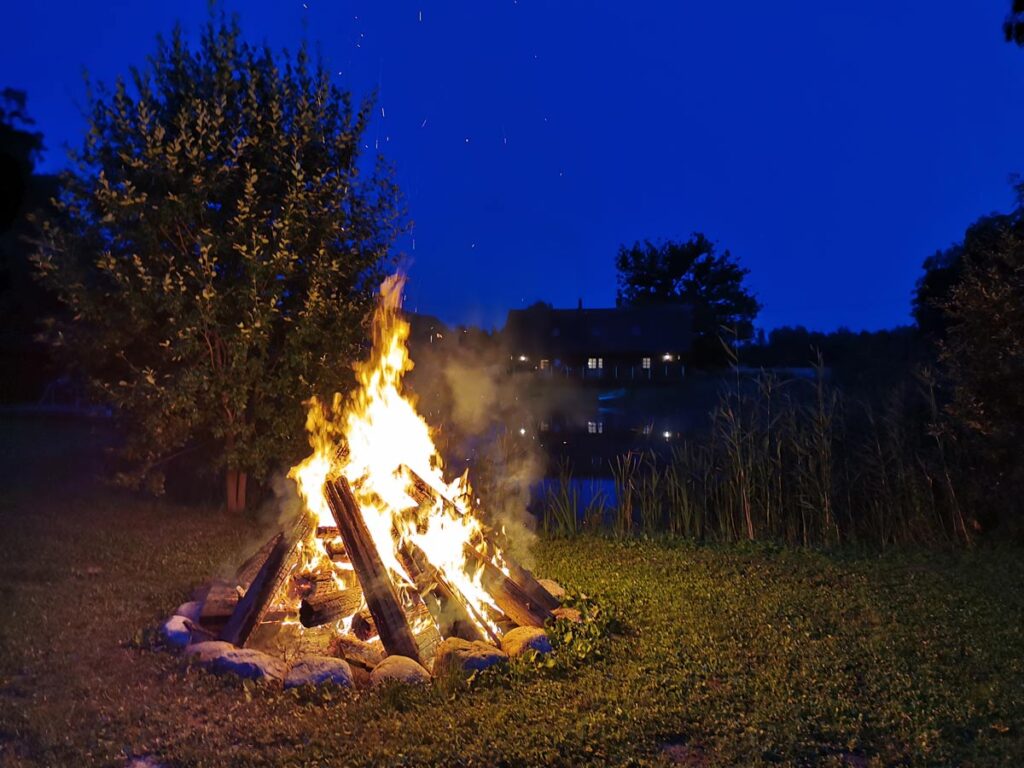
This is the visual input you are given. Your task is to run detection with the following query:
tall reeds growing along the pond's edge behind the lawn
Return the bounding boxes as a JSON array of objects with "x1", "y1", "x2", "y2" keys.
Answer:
[{"x1": 544, "y1": 361, "x2": 971, "y2": 547}]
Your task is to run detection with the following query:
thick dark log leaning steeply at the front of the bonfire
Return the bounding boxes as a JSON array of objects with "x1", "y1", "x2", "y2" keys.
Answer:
[{"x1": 325, "y1": 477, "x2": 420, "y2": 663}]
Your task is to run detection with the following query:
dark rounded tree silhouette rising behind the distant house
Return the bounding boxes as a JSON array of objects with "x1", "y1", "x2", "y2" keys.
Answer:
[{"x1": 615, "y1": 232, "x2": 761, "y2": 365}]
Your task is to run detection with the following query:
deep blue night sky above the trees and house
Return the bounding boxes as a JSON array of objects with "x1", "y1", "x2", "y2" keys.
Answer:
[{"x1": 0, "y1": 0, "x2": 1024, "y2": 330}]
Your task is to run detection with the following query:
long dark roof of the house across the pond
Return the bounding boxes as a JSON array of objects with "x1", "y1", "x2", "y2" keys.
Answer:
[{"x1": 504, "y1": 305, "x2": 692, "y2": 357}]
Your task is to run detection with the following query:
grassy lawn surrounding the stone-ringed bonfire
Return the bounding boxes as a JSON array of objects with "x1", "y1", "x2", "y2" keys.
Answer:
[{"x1": 0, "y1": 419, "x2": 1024, "y2": 766}]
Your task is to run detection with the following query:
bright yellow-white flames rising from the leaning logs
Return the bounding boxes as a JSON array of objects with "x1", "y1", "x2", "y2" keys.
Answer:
[{"x1": 290, "y1": 275, "x2": 506, "y2": 634}]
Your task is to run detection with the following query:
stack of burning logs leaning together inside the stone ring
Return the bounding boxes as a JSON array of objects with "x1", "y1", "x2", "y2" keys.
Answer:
[{"x1": 200, "y1": 467, "x2": 558, "y2": 664}]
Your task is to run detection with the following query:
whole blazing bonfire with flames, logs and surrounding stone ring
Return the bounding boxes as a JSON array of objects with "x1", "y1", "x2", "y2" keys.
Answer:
[{"x1": 164, "y1": 276, "x2": 563, "y2": 684}]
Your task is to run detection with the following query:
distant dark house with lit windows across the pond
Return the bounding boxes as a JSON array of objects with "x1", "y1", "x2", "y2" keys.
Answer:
[{"x1": 503, "y1": 304, "x2": 692, "y2": 382}]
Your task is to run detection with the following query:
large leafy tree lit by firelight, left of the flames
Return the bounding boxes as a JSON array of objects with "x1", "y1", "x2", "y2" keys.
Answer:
[{"x1": 36, "y1": 13, "x2": 401, "y2": 511}]
